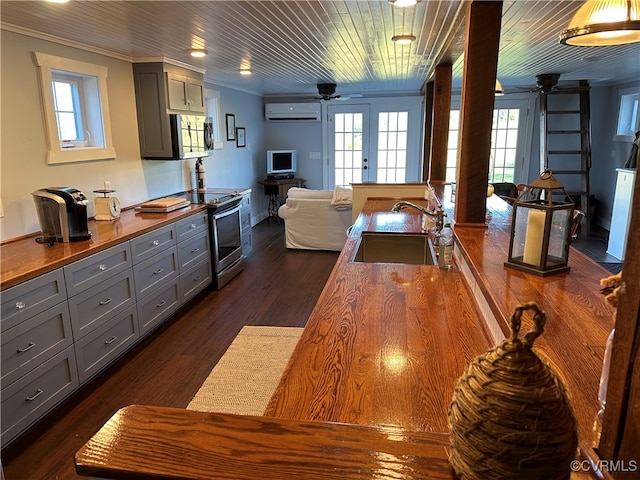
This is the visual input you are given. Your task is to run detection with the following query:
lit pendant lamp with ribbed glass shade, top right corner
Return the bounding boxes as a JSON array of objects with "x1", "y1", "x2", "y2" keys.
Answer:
[{"x1": 560, "y1": 0, "x2": 640, "y2": 47}]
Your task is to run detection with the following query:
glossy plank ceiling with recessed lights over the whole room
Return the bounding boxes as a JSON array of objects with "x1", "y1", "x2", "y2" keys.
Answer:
[{"x1": 0, "y1": 0, "x2": 640, "y2": 97}]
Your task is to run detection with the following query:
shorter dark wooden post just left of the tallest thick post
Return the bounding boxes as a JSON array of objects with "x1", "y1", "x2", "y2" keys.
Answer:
[{"x1": 429, "y1": 63, "x2": 451, "y2": 184}]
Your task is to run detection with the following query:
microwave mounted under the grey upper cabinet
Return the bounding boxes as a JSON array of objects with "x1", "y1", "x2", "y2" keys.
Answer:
[{"x1": 143, "y1": 113, "x2": 213, "y2": 160}]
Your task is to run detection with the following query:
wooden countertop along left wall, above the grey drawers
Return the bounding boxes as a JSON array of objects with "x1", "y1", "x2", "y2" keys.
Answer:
[{"x1": 0, "y1": 204, "x2": 207, "y2": 290}]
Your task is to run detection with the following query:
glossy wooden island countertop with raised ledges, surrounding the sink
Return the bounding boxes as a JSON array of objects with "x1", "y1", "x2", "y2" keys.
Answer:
[{"x1": 76, "y1": 191, "x2": 613, "y2": 479}]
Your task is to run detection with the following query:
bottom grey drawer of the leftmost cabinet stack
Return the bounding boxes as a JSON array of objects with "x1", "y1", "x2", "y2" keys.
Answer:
[{"x1": 2, "y1": 347, "x2": 79, "y2": 445}]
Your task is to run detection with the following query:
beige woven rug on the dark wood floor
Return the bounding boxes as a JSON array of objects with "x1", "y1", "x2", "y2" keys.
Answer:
[{"x1": 187, "y1": 326, "x2": 304, "y2": 415}]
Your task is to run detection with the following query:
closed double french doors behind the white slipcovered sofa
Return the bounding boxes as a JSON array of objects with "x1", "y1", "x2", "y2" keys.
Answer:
[{"x1": 327, "y1": 97, "x2": 422, "y2": 188}]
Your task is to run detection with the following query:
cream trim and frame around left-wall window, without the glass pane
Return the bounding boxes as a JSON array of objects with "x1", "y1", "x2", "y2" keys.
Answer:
[{"x1": 34, "y1": 52, "x2": 116, "y2": 164}]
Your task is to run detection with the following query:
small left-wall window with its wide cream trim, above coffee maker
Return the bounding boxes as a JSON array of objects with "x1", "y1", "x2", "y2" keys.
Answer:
[{"x1": 34, "y1": 52, "x2": 115, "y2": 163}]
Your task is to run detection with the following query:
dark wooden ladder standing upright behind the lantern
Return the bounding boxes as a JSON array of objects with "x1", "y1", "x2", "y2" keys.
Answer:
[{"x1": 540, "y1": 80, "x2": 591, "y2": 235}]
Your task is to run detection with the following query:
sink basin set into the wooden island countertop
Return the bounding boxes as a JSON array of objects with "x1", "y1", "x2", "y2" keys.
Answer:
[{"x1": 353, "y1": 232, "x2": 437, "y2": 265}]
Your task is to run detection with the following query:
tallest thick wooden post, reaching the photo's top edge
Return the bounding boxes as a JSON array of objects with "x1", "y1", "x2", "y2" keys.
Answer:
[{"x1": 455, "y1": 1, "x2": 502, "y2": 225}]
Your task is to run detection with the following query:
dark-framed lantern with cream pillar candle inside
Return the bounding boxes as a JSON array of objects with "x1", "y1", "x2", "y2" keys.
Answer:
[{"x1": 504, "y1": 169, "x2": 575, "y2": 277}]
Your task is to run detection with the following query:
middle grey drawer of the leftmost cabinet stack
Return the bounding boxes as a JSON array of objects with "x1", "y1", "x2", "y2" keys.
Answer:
[{"x1": 0, "y1": 302, "x2": 73, "y2": 385}]
